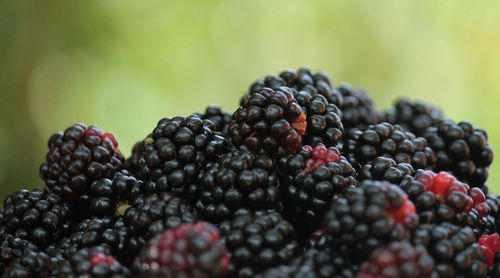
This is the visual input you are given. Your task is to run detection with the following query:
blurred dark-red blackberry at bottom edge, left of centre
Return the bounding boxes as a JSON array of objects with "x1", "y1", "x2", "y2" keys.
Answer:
[{"x1": 134, "y1": 222, "x2": 229, "y2": 278}]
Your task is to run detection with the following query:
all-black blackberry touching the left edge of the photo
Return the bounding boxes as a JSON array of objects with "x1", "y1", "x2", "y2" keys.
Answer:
[{"x1": 2, "y1": 188, "x2": 72, "y2": 248}]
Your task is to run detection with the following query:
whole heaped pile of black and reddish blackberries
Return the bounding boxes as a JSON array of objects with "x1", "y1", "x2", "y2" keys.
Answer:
[{"x1": 0, "y1": 68, "x2": 500, "y2": 278}]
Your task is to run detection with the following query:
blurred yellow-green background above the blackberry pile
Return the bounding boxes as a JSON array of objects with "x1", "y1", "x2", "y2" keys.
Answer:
[{"x1": 0, "y1": 0, "x2": 500, "y2": 204}]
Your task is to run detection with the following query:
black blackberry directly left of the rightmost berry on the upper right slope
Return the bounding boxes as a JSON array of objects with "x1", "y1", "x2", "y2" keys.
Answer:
[{"x1": 344, "y1": 123, "x2": 436, "y2": 184}]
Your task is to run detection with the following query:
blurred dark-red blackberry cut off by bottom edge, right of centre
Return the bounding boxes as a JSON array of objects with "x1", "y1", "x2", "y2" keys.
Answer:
[{"x1": 356, "y1": 241, "x2": 438, "y2": 278}]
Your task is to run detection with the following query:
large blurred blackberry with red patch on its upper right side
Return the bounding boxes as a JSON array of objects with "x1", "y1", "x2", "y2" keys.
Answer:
[{"x1": 316, "y1": 181, "x2": 418, "y2": 264}]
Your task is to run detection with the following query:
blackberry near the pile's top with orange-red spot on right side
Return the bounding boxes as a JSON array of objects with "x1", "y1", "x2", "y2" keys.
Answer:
[{"x1": 229, "y1": 87, "x2": 307, "y2": 155}]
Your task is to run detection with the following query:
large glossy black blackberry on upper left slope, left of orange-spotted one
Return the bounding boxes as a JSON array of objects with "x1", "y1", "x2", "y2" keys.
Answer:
[{"x1": 137, "y1": 116, "x2": 229, "y2": 201}]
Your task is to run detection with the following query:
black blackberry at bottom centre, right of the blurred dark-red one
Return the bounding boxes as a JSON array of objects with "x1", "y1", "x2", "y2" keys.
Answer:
[{"x1": 219, "y1": 212, "x2": 299, "y2": 278}]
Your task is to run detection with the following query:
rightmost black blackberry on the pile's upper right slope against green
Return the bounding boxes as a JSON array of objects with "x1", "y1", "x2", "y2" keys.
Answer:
[{"x1": 422, "y1": 120, "x2": 493, "y2": 190}]
